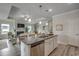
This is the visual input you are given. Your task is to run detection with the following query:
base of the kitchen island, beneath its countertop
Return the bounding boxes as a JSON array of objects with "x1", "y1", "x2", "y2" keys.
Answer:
[{"x1": 21, "y1": 36, "x2": 57, "y2": 56}]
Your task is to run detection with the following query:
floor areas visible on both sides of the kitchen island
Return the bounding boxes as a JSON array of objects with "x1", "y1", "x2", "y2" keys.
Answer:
[{"x1": 0, "y1": 40, "x2": 79, "y2": 56}]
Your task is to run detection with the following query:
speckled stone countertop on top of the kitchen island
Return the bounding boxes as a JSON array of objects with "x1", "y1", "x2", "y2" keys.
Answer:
[{"x1": 21, "y1": 35, "x2": 57, "y2": 45}]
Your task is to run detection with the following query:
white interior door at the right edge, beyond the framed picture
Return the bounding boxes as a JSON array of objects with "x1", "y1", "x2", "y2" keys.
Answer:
[{"x1": 69, "y1": 19, "x2": 79, "y2": 46}]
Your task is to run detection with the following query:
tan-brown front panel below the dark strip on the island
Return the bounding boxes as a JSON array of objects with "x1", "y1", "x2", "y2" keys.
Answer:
[{"x1": 31, "y1": 42, "x2": 44, "y2": 56}]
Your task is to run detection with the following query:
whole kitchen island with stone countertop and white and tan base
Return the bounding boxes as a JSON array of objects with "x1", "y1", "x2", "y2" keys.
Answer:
[{"x1": 21, "y1": 35, "x2": 57, "y2": 56}]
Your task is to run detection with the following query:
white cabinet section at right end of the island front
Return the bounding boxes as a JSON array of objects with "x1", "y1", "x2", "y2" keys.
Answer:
[{"x1": 45, "y1": 36, "x2": 57, "y2": 56}]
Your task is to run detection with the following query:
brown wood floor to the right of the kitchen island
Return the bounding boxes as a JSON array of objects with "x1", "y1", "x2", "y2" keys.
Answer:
[{"x1": 49, "y1": 44, "x2": 79, "y2": 56}]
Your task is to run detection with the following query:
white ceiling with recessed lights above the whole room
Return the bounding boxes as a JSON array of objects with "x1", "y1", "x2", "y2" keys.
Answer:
[{"x1": 0, "y1": 3, "x2": 79, "y2": 22}]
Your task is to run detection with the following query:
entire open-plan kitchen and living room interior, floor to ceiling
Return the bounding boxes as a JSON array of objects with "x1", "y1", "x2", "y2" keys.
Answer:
[{"x1": 0, "y1": 3, "x2": 79, "y2": 56}]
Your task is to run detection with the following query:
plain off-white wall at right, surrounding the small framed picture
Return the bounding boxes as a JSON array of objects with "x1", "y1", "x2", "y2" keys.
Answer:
[{"x1": 53, "y1": 9, "x2": 79, "y2": 46}]
